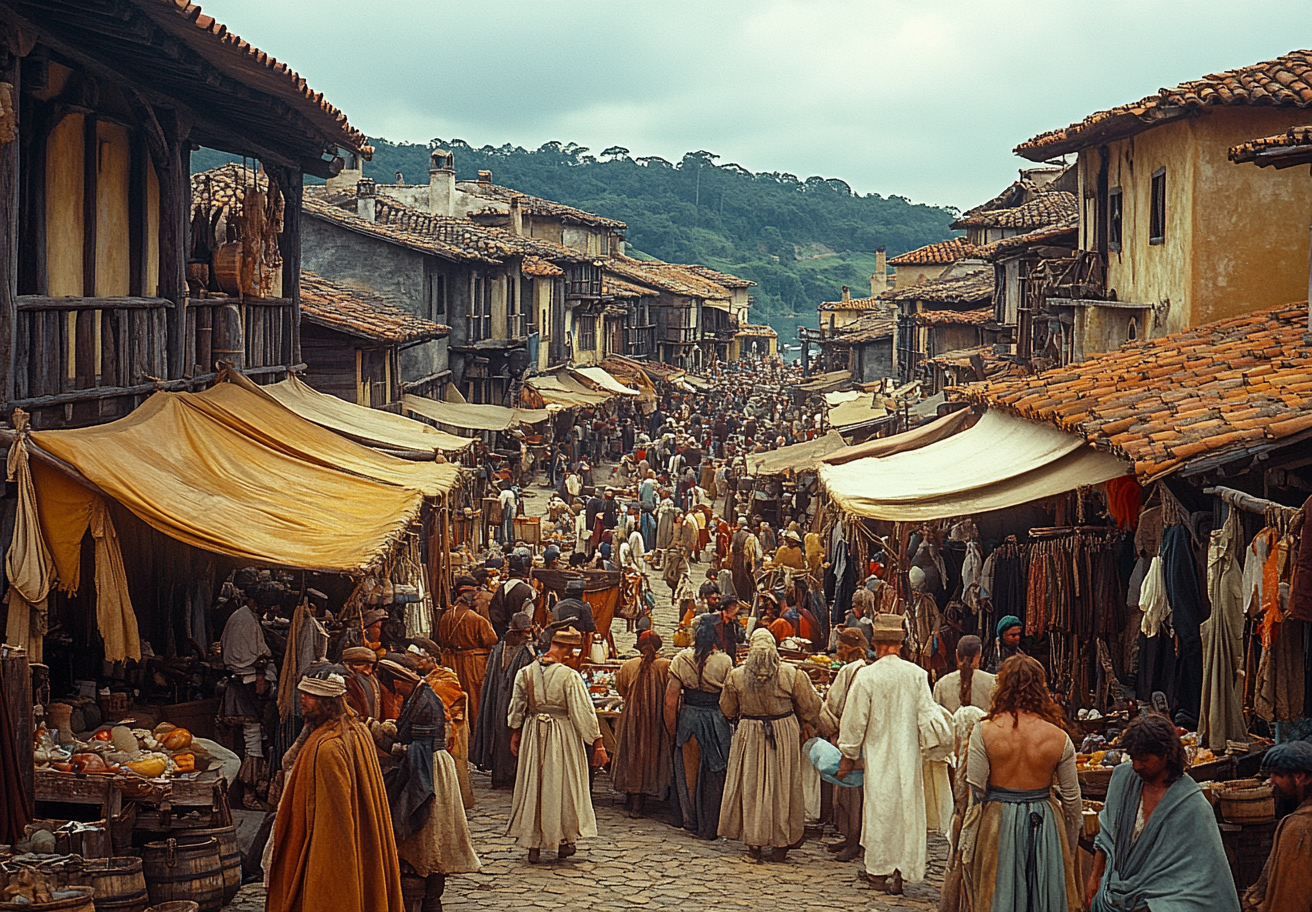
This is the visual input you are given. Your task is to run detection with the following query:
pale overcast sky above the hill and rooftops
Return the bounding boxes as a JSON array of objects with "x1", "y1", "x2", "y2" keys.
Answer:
[{"x1": 203, "y1": 0, "x2": 1312, "y2": 209}]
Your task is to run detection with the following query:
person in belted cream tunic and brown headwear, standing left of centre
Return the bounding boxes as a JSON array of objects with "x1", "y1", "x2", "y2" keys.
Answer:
[{"x1": 506, "y1": 627, "x2": 606, "y2": 863}]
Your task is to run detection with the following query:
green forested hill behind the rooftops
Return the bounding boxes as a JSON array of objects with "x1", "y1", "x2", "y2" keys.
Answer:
[{"x1": 192, "y1": 139, "x2": 956, "y2": 341}]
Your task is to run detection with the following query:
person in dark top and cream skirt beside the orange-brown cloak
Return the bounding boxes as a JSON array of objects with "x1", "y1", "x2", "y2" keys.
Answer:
[{"x1": 378, "y1": 657, "x2": 483, "y2": 912}]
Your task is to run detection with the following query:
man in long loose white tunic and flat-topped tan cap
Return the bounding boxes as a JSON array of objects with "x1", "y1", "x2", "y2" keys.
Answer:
[{"x1": 838, "y1": 614, "x2": 951, "y2": 895}]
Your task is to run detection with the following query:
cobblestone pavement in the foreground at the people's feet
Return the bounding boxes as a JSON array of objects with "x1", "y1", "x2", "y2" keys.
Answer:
[{"x1": 227, "y1": 770, "x2": 947, "y2": 912}]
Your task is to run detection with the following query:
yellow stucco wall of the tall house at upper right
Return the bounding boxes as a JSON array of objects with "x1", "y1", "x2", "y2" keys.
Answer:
[{"x1": 1078, "y1": 108, "x2": 1312, "y2": 335}]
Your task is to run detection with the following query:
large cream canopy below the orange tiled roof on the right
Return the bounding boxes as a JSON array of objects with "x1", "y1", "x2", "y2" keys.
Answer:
[{"x1": 820, "y1": 411, "x2": 1130, "y2": 521}]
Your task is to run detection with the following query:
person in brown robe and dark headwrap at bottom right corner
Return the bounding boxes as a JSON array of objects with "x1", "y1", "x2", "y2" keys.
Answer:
[{"x1": 1244, "y1": 741, "x2": 1312, "y2": 912}]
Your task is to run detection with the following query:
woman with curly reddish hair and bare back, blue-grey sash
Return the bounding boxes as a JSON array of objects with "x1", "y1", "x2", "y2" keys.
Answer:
[{"x1": 960, "y1": 655, "x2": 1081, "y2": 912}]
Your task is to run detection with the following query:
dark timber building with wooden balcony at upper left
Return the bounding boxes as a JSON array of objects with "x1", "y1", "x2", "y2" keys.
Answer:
[{"x1": 0, "y1": 0, "x2": 370, "y2": 426}]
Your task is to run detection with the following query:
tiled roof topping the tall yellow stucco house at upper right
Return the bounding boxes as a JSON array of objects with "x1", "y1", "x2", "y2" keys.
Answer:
[{"x1": 1015, "y1": 50, "x2": 1312, "y2": 161}]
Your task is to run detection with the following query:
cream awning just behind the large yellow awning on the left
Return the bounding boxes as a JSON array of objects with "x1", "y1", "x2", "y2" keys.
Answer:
[{"x1": 257, "y1": 377, "x2": 474, "y2": 455}]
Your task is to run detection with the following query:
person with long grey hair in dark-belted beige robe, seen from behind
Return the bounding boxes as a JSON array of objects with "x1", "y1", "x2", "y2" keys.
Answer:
[{"x1": 719, "y1": 629, "x2": 820, "y2": 861}]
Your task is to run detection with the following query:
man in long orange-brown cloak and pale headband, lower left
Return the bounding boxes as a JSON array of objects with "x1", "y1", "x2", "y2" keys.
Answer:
[{"x1": 265, "y1": 665, "x2": 393, "y2": 912}]
